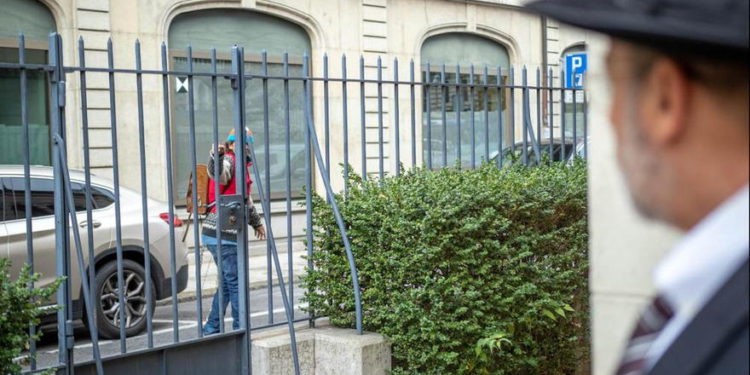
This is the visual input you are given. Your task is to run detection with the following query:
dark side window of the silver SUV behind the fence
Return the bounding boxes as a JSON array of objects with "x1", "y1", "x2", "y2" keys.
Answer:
[{"x1": 5, "y1": 177, "x2": 86, "y2": 219}]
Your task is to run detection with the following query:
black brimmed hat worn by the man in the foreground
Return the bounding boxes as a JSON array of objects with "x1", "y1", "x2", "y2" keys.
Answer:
[{"x1": 526, "y1": 0, "x2": 750, "y2": 59}]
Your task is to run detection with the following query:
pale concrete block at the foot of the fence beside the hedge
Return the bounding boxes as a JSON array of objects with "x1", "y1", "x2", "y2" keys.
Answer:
[{"x1": 252, "y1": 321, "x2": 391, "y2": 375}]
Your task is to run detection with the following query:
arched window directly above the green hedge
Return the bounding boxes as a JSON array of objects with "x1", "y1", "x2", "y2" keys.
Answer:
[{"x1": 421, "y1": 33, "x2": 510, "y2": 166}]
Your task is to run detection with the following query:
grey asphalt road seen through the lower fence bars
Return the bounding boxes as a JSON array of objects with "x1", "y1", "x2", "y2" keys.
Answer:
[{"x1": 26, "y1": 286, "x2": 307, "y2": 368}]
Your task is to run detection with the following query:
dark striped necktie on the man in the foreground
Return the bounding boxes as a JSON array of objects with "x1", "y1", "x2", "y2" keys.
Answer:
[{"x1": 617, "y1": 296, "x2": 674, "y2": 375}]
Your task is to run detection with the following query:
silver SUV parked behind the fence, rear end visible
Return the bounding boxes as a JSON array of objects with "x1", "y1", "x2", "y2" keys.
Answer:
[{"x1": 0, "y1": 165, "x2": 188, "y2": 338}]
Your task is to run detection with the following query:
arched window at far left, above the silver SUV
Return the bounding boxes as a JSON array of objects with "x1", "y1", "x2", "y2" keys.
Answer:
[{"x1": 0, "y1": 0, "x2": 56, "y2": 165}]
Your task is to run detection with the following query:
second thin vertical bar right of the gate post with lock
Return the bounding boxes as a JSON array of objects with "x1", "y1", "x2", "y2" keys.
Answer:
[{"x1": 284, "y1": 52, "x2": 294, "y2": 318}]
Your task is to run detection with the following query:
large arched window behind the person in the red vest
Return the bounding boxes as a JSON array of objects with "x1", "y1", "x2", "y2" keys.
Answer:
[{"x1": 169, "y1": 9, "x2": 310, "y2": 197}]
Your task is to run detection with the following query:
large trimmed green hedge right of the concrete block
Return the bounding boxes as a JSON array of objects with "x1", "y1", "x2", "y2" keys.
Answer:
[{"x1": 303, "y1": 161, "x2": 589, "y2": 375}]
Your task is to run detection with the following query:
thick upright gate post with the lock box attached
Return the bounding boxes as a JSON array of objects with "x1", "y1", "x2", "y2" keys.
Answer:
[{"x1": 232, "y1": 46, "x2": 251, "y2": 374}]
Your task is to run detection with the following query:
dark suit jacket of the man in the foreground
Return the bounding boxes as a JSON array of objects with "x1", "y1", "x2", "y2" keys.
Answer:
[{"x1": 649, "y1": 261, "x2": 750, "y2": 375}]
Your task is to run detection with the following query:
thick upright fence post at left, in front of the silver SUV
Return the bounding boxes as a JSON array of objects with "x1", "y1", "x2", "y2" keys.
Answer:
[{"x1": 48, "y1": 33, "x2": 74, "y2": 375}]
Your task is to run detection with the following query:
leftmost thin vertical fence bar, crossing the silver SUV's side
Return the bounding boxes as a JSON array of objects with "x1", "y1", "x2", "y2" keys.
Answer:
[{"x1": 18, "y1": 34, "x2": 37, "y2": 371}]
